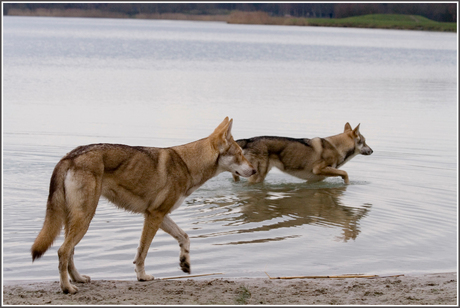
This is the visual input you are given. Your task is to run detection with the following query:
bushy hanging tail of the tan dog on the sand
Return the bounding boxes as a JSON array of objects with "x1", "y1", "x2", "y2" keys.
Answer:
[{"x1": 30, "y1": 160, "x2": 68, "y2": 262}]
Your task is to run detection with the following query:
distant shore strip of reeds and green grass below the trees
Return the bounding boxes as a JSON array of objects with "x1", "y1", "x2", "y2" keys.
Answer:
[{"x1": 7, "y1": 8, "x2": 457, "y2": 32}]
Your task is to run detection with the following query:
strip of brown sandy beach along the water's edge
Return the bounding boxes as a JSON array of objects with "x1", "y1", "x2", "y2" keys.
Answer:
[{"x1": 3, "y1": 272, "x2": 458, "y2": 306}]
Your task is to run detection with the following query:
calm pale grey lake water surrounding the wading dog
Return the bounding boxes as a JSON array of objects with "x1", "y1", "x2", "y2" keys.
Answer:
[{"x1": 2, "y1": 16, "x2": 458, "y2": 281}]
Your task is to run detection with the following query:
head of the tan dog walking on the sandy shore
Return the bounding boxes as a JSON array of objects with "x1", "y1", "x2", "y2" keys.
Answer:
[{"x1": 210, "y1": 117, "x2": 256, "y2": 177}]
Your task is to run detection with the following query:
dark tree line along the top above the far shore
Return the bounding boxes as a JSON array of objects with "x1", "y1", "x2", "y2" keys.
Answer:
[{"x1": 3, "y1": 2, "x2": 457, "y2": 22}]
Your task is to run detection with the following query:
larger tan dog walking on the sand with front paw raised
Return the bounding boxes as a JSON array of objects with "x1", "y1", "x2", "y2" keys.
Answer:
[{"x1": 31, "y1": 117, "x2": 256, "y2": 293}]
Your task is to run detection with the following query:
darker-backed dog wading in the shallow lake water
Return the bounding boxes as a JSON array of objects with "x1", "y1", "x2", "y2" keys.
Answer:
[{"x1": 233, "y1": 123, "x2": 373, "y2": 184}]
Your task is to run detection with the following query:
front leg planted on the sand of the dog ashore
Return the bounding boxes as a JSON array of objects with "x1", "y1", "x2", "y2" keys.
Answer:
[{"x1": 133, "y1": 211, "x2": 164, "y2": 281}]
